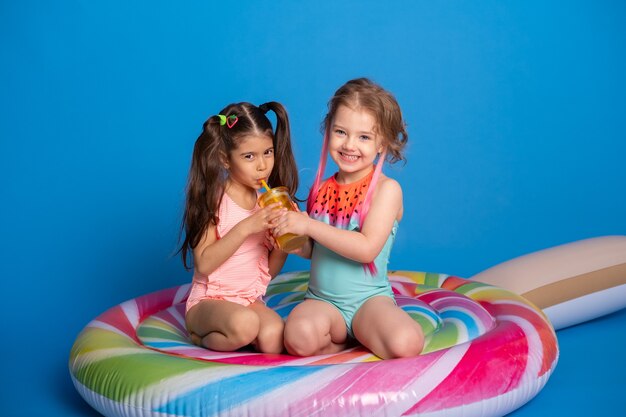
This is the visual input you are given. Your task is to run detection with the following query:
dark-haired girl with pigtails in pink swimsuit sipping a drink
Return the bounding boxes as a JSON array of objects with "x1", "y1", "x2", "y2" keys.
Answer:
[{"x1": 180, "y1": 102, "x2": 298, "y2": 353}]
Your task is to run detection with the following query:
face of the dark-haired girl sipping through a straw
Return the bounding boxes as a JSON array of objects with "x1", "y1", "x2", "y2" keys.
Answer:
[{"x1": 226, "y1": 135, "x2": 274, "y2": 190}]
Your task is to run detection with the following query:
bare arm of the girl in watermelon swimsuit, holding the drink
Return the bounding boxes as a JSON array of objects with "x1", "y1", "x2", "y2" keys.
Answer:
[{"x1": 275, "y1": 176, "x2": 402, "y2": 263}]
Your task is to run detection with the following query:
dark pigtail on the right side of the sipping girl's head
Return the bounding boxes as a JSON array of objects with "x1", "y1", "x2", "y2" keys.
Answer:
[{"x1": 259, "y1": 101, "x2": 298, "y2": 200}]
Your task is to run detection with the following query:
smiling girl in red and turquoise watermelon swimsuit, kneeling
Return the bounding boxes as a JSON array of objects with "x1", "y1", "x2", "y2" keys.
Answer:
[{"x1": 270, "y1": 78, "x2": 424, "y2": 359}]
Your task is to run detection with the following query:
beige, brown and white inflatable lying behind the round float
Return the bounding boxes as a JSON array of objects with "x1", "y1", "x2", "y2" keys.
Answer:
[{"x1": 470, "y1": 236, "x2": 626, "y2": 329}]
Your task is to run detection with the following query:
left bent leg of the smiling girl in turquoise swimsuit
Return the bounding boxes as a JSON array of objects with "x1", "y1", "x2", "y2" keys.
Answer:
[{"x1": 285, "y1": 299, "x2": 347, "y2": 356}]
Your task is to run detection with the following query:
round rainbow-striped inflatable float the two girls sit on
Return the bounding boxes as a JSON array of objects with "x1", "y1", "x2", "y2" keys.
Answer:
[{"x1": 69, "y1": 272, "x2": 558, "y2": 417}]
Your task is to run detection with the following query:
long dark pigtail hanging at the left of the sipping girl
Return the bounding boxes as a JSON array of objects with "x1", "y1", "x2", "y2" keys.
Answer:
[{"x1": 179, "y1": 116, "x2": 226, "y2": 270}]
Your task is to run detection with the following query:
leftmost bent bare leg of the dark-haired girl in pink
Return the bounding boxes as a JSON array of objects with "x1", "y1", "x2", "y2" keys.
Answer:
[{"x1": 185, "y1": 300, "x2": 260, "y2": 352}]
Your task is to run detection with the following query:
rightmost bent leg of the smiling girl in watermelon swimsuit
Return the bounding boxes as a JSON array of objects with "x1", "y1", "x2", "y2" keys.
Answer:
[{"x1": 352, "y1": 296, "x2": 424, "y2": 359}]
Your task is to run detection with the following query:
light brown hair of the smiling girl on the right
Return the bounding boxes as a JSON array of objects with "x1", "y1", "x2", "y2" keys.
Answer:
[{"x1": 322, "y1": 78, "x2": 409, "y2": 163}]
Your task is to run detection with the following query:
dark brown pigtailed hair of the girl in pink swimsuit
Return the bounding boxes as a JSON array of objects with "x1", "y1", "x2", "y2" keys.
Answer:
[{"x1": 179, "y1": 101, "x2": 298, "y2": 269}]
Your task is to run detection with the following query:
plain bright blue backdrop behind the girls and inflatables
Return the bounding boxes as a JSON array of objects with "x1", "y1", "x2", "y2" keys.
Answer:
[{"x1": 0, "y1": 0, "x2": 626, "y2": 417}]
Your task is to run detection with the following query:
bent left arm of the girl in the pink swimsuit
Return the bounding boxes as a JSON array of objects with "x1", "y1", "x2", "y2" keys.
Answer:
[{"x1": 193, "y1": 204, "x2": 276, "y2": 275}]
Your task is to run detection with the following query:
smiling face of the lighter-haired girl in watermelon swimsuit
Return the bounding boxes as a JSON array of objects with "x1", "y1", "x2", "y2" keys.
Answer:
[{"x1": 328, "y1": 105, "x2": 383, "y2": 184}]
